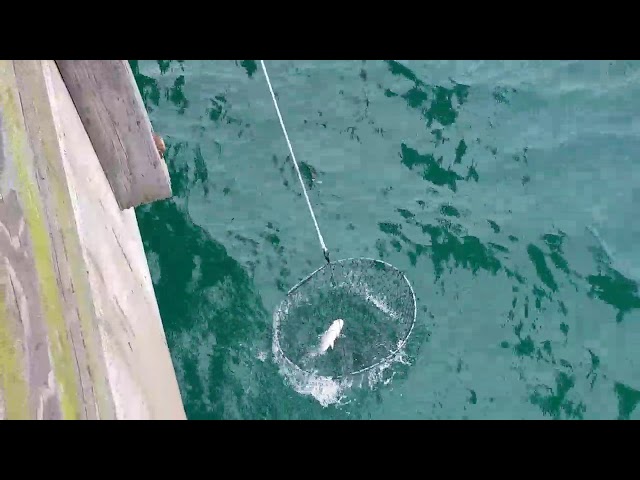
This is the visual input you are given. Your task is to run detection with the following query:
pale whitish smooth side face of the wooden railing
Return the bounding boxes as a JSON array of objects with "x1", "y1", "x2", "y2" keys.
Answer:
[{"x1": 43, "y1": 61, "x2": 186, "y2": 419}]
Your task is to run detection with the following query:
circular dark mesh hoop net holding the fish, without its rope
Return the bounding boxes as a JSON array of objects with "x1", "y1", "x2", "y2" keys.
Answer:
[{"x1": 274, "y1": 258, "x2": 416, "y2": 378}]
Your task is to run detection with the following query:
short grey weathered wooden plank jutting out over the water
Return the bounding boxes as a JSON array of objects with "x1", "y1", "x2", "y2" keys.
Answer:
[{"x1": 56, "y1": 60, "x2": 172, "y2": 209}]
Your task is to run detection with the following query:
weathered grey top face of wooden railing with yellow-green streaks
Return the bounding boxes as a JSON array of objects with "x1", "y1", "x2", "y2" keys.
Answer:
[{"x1": 0, "y1": 60, "x2": 104, "y2": 419}]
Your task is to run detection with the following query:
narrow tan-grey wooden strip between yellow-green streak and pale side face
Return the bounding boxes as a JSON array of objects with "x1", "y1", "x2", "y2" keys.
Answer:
[{"x1": 14, "y1": 60, "x2": 113, "y2": 419}]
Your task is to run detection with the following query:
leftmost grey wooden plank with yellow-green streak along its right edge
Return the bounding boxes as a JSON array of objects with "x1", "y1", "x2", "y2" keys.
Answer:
[{"x1": 0, "y1": 60, "x2": 84, "y2": 419}]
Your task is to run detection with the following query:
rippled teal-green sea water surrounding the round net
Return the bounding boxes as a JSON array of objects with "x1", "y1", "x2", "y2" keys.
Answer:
[{"x1": 131, "y1": 60, "x2": 640, "y2": 419}]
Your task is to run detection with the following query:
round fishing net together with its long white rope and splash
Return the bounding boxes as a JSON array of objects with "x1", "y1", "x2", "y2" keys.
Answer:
[{"x1": 260, "y1": 60, "x2": 417, "y2": 406}]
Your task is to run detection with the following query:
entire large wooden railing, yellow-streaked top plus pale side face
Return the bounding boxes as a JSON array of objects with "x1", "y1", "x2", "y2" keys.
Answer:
[{"x1": 0, "y1": 60, "x2": 185, "y2": 419}]
